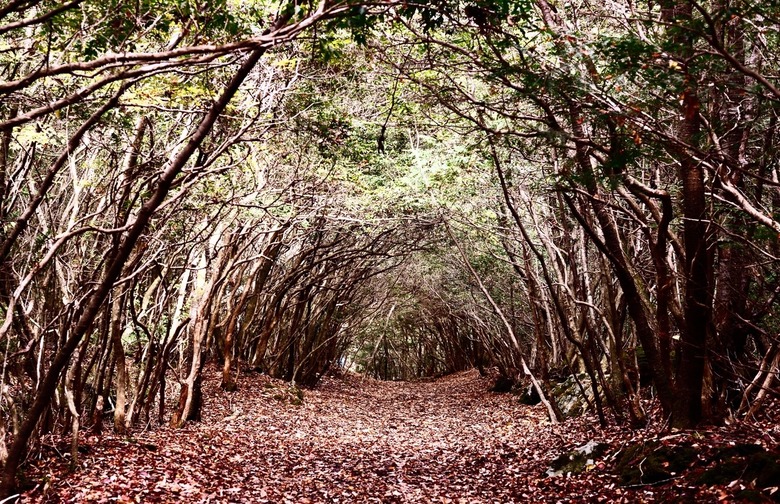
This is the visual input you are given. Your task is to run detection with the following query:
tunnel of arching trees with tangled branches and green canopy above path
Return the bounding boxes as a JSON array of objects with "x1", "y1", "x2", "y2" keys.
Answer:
[{"x1": 0, "y1": 0, "x2": 780, "y2": 495}]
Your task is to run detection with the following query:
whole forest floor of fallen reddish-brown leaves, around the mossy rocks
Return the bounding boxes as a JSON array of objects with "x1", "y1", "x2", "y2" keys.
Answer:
[{"x1": 22, "y1": 370, "x2": 780, "y2": 504}]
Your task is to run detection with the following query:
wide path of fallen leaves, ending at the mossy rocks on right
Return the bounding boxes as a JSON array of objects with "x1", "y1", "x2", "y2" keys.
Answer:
[{"x1": 25, "y1": 371, "x2": 588, "y2": 503}]
